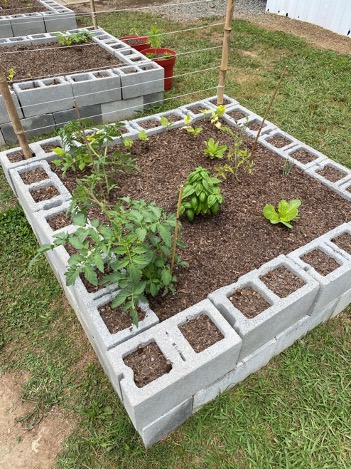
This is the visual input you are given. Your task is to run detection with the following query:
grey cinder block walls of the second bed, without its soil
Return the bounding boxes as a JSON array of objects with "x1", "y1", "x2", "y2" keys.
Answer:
[{"x1": 0, "y1": 28, "x2": 164, "y2": 143}]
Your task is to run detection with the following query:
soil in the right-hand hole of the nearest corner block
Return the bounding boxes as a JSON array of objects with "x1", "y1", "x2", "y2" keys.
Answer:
[{"x1": 179, "y1": 314, "x2": 224, "y2": 353}]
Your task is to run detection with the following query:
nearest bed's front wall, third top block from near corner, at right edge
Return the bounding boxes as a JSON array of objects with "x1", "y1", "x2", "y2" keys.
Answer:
[{"x1": 288, "y1": 236, "x2": 351, "y2": 315}]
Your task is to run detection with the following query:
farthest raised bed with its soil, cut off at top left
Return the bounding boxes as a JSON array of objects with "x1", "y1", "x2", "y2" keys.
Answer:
[{"x1": 0, "y1": 0, "x2": 77, "y2": 38}]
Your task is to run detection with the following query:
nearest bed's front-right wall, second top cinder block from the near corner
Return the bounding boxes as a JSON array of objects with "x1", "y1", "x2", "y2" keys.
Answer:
[{"x1": 209, "y1": 255, "x2": 319, "y2": 360}]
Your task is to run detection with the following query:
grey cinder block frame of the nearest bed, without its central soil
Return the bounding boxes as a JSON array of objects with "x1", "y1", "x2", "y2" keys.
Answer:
[{"x1": 0, "y1": 96, "x2": 351, "y2": 446}]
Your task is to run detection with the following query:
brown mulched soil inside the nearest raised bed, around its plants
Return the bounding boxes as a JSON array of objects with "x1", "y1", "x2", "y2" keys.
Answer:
[{"x1": 48, "y1": 119, "x2": 351, "y2": 320}]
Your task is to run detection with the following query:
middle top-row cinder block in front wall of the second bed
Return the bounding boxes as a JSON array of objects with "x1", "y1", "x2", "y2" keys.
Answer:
[{"x1": 66, "y1": 70, "x2": 122, "y2": 106}]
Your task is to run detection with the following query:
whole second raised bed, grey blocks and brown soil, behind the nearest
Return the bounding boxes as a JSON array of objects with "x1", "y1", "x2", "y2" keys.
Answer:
[{"x1": 0, "y1": 28, "x2": 164, "y2": 145}]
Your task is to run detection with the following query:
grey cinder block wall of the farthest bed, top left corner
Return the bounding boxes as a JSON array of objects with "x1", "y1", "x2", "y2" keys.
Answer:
[{"x1": 0, "y1": 0, "x2": 77, "y2": 38}]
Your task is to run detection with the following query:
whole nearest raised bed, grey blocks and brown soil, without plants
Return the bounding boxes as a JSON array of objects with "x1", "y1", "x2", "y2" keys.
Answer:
[{"x1": 0, "y1": 97, "x2": 351, "y2": 446}]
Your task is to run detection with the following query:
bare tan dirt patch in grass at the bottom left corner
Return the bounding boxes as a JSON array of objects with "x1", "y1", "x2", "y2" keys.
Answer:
[{"x1": 0, "y1": 373, "x2": 74, "y2": 469}]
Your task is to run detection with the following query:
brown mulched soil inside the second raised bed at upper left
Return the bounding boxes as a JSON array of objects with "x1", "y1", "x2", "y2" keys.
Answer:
[{"x1": 0, "y1": 41, "x2": 124, "y2": 82}]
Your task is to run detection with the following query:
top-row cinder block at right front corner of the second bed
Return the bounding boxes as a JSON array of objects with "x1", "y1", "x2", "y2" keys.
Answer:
[{"x1": 115, "y1": 62, "x2": 164, "y2": 99}]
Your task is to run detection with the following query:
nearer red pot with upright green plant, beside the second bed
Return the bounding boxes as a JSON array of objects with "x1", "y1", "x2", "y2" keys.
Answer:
[{"x1": 142, "y1": 26, "x2": 176, "y2": 91}]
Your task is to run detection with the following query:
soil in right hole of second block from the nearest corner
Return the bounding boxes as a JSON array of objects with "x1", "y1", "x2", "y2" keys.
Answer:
[{"x1": 260, "y1": 266, "x2": 305, "y2": 298}]
